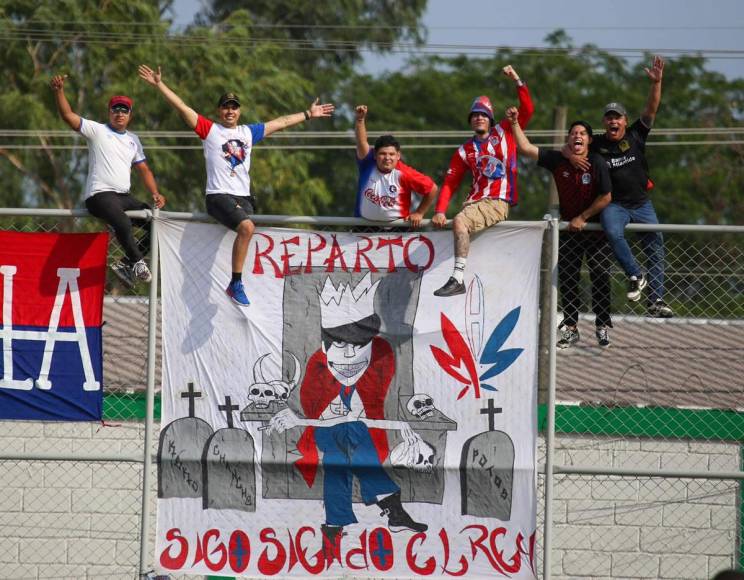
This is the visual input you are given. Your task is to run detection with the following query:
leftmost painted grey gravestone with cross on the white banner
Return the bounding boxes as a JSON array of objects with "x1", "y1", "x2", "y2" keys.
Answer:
[{"x1": 157, "y1": 383, "x2": 212, "y2": 498}]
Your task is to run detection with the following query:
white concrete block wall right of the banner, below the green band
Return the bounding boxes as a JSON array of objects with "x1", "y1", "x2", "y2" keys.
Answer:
[{"x1": 541, "y1": 435, "x2": 741, "y2": 580}]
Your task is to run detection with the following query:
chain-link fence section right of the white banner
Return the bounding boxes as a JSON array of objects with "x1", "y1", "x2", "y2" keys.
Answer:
[{"x1": 550, "y1": 226, "x2": 744, "y2": 578}]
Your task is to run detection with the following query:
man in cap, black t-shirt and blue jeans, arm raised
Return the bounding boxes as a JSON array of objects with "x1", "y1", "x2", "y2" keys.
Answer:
[{"x1": 591, "y1": 56, "x2": 674, "y2": 318}]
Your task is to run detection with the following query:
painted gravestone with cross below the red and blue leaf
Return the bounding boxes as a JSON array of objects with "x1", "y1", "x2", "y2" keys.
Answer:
[{"x1": 460, "y1": 399, "x2": 514, "y2": 521}]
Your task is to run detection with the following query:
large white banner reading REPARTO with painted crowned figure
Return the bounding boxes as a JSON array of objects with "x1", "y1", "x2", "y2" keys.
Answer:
[{"x1": 156, "y1": 220, "x2": 543, "y2": 578}]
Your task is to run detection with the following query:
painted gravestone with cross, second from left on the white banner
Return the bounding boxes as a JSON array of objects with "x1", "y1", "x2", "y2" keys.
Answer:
[{"x1": 202, "y1": 396, "x2": 256, "y2": 512}]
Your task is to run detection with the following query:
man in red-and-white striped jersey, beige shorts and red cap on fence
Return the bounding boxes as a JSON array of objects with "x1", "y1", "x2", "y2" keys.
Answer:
[{"x1": 432, "y1": 65, "x2": 535, "y2": 296}]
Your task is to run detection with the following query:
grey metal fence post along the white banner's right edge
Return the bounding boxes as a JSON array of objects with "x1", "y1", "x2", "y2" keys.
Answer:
[{"x1": 543, "y1": 218, "x2": 559, "y2": 580}]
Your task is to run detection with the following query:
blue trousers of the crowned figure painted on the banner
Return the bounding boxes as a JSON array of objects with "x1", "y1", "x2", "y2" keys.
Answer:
[{"x1": 315, "y1": 421, "x2": 400, "y2": 526}]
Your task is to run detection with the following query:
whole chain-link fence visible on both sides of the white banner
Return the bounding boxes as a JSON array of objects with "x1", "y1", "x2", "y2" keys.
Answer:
[{"x1": 0, "y1": 210, "x2": 744, "y2": 578}]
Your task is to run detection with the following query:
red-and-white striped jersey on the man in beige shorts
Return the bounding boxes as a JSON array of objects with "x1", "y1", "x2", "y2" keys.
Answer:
[{"x1": 436, "y1": 84, "x2": 535, "y2": 213}]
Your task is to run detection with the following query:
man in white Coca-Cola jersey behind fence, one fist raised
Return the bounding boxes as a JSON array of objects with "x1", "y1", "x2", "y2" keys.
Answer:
[{"x1": 354, "y1": 105, "x2": 437, "y2": 228}]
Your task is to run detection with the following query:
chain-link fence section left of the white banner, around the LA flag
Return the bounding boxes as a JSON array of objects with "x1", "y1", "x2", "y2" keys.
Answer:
[{"x1": 0, "y1": 212, "x2": 148, "y2": 580}]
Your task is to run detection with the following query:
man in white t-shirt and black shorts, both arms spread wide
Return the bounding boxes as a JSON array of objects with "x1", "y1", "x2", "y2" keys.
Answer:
[{"x1": 139, "y1": 65, "x2": 334, "y2": 306}]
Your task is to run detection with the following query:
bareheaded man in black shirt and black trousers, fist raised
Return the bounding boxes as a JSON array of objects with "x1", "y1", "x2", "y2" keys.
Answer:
[{"x1": 506, "y1": 107, "x2": 612, "y2": 348}]
